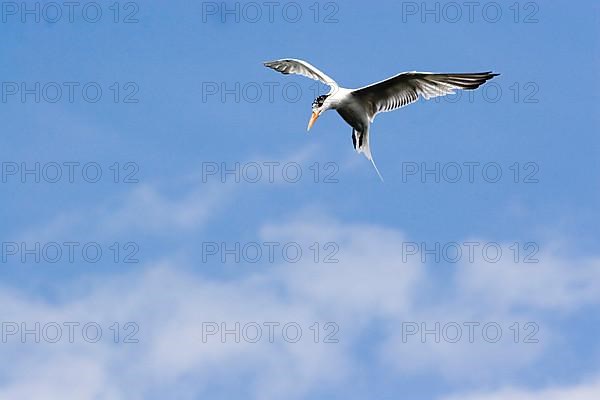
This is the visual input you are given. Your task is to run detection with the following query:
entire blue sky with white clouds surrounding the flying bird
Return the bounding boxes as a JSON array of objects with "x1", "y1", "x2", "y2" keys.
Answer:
[{"x1": 0, "y1": 1, "x2": 600, "y2": 400}]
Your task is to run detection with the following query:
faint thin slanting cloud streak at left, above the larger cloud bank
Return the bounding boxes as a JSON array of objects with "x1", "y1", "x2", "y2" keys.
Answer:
[{"x1": 18, "y1": 181, "x2": 233, "y2": 242}]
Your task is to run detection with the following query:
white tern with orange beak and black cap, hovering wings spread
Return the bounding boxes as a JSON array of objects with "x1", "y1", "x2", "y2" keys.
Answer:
[{"x1": 264, "y1": 58, "x2": 499, "y2": 180}]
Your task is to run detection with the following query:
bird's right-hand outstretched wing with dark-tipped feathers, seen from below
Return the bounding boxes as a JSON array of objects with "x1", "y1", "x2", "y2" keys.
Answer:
[{"x1": 352, "y1": 71, "x2": 499, "y2": 120}]
